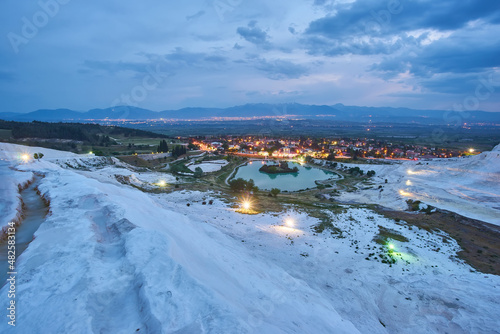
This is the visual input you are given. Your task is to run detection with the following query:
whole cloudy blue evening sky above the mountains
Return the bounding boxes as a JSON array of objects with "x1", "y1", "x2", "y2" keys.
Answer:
[{"x1": 0, "y1": 0, "x2": 500, "y2": 112}]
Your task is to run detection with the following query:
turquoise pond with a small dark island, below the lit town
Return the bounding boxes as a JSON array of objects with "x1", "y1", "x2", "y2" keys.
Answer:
[{"x1": 230, "y1": 161, "x2": 340, "y2": 191}]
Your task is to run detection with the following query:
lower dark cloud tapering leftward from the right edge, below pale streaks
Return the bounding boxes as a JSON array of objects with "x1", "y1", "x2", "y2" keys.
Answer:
[{"x1": 371, "y1": 27, "x2": 500, "y2": 96}]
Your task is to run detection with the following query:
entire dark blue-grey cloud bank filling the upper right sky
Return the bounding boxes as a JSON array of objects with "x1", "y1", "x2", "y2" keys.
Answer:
[{"x1": 302, "y1": 0, "x2": 500, "y2": 103}]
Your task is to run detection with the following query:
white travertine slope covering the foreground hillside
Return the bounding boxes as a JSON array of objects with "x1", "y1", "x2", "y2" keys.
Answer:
[{"x1": 0, "y1": 144, "x2": 500, "y2": 334}]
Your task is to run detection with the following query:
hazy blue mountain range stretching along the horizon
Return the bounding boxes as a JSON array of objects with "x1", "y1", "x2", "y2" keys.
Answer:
[{"x1": 0, "y1": 103, "x2": 500, "y2": 124}]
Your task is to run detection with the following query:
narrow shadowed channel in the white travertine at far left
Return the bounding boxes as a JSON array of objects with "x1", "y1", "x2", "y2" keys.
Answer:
[{"x1": 0, "y1": 177, "x2": 48, "y2": 286}]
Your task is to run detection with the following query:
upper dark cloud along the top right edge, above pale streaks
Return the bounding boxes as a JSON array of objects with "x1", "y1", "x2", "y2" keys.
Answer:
[{"x1": 302, "y1": 0, "x2": 500, "y2": 56}]
